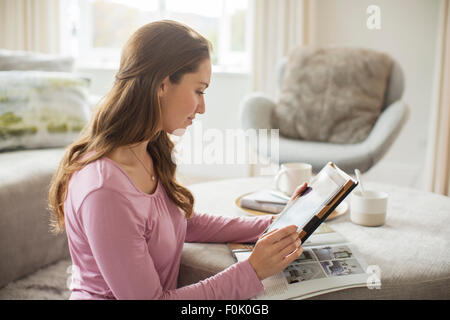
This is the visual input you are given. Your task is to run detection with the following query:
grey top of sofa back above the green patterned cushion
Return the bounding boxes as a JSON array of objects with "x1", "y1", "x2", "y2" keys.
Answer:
[{"x1": 0, "y1": 49, "x2": 74, "y2": 72}]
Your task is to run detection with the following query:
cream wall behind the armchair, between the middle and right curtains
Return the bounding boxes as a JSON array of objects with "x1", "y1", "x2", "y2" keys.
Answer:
[{"x1": 309, "y1": 0, "x2": 440, "y2": 187}]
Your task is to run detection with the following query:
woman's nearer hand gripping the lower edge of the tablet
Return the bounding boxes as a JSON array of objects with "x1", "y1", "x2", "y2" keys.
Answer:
[{"x1": 248, "y1": 225, "x2": 303, "y2": 280}]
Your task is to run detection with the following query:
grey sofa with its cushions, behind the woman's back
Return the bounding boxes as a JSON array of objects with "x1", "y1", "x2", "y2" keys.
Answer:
[{"x1": 0, "y1": 49, "x2": 94, "y2": 288}]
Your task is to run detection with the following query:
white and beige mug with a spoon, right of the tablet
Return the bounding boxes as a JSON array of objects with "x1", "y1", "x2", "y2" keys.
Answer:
[{"x1": 350, "y1": 190, "x2": 388, "y2": 227}]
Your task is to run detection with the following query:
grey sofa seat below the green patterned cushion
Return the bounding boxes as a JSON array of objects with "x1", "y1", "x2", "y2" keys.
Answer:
[{"x1": 0, "y1": 149, "x2": 69, "y2": 287}]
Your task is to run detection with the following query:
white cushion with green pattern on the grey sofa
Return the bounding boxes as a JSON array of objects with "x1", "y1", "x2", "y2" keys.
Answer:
[{"x1": 0, "y1": 71, "x2": 90, "y2": 151}]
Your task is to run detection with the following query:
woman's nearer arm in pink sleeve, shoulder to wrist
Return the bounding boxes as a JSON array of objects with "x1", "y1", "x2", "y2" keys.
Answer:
[{"x1": 79, "y1": 189, "x2": 264, "y2": 299}]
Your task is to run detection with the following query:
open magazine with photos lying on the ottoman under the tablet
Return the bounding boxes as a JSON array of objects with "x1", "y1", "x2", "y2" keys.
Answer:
[{"x1": 229, "y1": 223, "x2": 369, "y2": 300}]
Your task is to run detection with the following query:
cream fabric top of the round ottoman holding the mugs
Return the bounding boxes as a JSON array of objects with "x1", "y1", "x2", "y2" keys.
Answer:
[{"x1": 188, "y1": 176, "x2": 450, "y2": 298}]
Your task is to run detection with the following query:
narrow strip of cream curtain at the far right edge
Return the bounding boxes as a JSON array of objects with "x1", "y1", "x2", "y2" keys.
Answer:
[{"x1": 425, "y1": 0, "x2": 450, "y2": 196}]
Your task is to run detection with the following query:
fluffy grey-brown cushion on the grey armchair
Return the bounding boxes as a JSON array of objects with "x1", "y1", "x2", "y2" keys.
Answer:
[{"x1": 272, "y1": 47, "x2": 392, "y2": 143}]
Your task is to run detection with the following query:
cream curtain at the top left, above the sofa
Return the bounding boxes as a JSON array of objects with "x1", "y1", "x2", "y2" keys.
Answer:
[{"x1": 0, "y1": 0, "x2": 61, "y2": 53}]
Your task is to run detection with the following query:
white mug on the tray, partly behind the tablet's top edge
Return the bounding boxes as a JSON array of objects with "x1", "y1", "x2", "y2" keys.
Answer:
[{"x1": 274, "y1": 162, "x2": 312, "y2": 196}]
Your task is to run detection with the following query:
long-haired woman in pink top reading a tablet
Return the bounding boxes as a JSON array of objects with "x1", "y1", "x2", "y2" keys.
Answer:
[{"x1": 49, "y1": 21, "x2": 302, "y2": 299}]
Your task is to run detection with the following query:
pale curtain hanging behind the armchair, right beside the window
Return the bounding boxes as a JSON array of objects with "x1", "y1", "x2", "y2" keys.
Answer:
[{"x1": 252, "y1": 0, "x2": 309, "y2": 98}]
